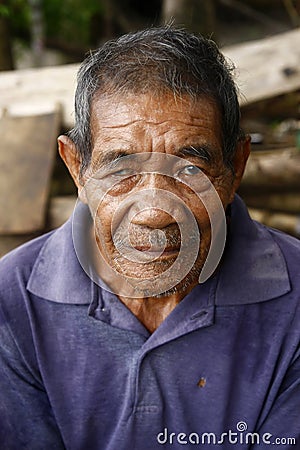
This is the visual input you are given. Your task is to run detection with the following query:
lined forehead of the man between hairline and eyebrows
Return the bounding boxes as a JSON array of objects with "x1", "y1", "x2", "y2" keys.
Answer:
[{"x1": 91, "y1": 93, "x2": 221, "y2": 151}]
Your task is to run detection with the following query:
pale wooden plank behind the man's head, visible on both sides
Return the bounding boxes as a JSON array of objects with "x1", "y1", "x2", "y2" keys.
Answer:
[{"x1": 0, "y1": 28, "x2": 300, "y2": 128}]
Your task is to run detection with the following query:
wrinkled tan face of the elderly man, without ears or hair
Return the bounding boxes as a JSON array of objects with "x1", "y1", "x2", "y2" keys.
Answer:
[{"x1": 61, "y1": 94, "x2": 248, "y2": 295}]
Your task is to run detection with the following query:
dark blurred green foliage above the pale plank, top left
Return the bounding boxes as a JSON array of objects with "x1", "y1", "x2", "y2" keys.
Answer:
[{"x1": 0, "y1": 0, "x2": 162, "y2": 60}]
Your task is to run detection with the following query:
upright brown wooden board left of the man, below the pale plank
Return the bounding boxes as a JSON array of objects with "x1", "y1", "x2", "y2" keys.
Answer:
[{"x1": 0, "y1": 107, "x2": 60, "y2": 234}]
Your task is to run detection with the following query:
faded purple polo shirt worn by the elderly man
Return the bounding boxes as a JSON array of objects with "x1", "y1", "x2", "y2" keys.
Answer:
[{"x1": 0, "y1": 197, "x2": 300, "y2": 450}]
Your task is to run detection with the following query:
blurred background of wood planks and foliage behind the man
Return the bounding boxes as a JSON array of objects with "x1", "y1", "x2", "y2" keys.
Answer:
[{"x1": 0, "y1": 0, "x2": 300, "y2": 256}]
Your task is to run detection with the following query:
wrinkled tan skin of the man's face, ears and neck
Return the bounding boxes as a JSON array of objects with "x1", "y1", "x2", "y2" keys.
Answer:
[{"x1": 59, "y1": 94, "x2": 250, "y2": 331}]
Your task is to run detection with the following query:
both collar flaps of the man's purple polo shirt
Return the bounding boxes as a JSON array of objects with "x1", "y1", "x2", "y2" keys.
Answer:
[{"x1": 27, "y1": 196, "x2": 290, "y2": 305}]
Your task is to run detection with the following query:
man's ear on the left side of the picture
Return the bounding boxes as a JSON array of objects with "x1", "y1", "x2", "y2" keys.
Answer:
[{"x1": 57, "y1": 135, "x2": 86, "y2": 203}]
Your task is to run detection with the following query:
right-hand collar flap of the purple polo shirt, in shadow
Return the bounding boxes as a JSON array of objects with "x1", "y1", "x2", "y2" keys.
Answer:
[{"x1": 216, "y1": 195, "x2": 291, "y2": 305}]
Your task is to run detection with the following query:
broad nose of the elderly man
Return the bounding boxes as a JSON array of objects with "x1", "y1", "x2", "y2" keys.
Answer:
[{"x1": 131, "y1": 173, "x2": 182, "y2": 228}]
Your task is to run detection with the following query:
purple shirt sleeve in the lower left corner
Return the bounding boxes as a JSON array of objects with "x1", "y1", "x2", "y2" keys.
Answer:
[{"x1": 0, "y1": 300, "x2": 65, "y2": 450}]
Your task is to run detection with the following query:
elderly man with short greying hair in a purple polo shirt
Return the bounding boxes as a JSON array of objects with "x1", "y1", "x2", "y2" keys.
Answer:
[{"x1": 0, "y1": 27, "x2": 300, "y2": 450}]
